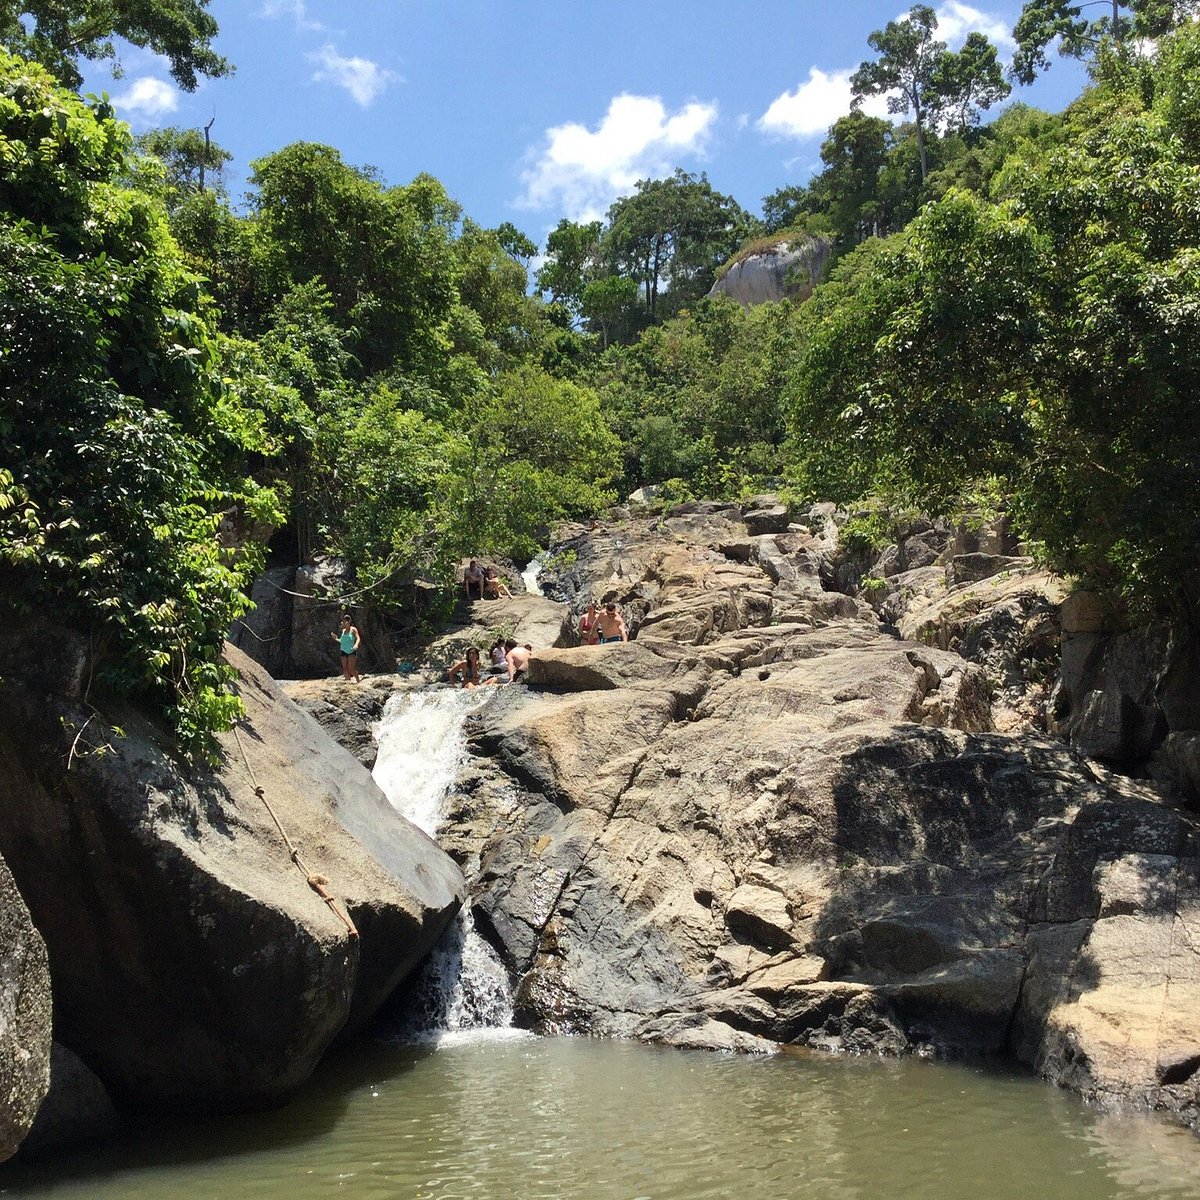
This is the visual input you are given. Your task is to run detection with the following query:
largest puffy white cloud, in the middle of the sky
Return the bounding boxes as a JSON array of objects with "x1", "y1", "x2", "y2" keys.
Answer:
[{"x1": 517, "y1": 94, "x2": 716, "y2": 221}]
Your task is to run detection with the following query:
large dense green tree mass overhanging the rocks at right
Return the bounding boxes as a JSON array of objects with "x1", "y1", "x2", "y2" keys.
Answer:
[{"x1": 793, "y1": 23, "x2": 1200, "y2": 607}]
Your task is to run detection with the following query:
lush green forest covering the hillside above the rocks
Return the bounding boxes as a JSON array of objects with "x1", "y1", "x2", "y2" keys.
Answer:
[{"x1": 0, "y1": 0, "x2": 1200, "y2": 748}]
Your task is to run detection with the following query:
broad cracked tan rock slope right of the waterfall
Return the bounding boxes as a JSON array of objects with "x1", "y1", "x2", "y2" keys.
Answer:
[{"x1": 422, "y1": 504, "x2": 1200, "y2": 1126}]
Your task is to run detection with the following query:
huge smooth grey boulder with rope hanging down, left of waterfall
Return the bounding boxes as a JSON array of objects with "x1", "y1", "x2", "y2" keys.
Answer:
[{"x1": 0, "y1": 630, "x2": 462, "y2": 1110}]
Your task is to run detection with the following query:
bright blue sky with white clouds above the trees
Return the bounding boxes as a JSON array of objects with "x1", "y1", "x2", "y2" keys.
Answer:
[{"x1": 85, "y1": 0, "x2": 1084, "y2": 241}]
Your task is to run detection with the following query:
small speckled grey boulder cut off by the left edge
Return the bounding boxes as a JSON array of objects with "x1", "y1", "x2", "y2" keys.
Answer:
[{"x1": 0, "y1": 858, "x2": 50, "y2": 1162}]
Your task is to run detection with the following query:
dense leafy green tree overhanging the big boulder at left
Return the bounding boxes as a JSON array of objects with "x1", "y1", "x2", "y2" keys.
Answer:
[{"x1": 0, "y1": 50, "x2": 278, "y2": 750}]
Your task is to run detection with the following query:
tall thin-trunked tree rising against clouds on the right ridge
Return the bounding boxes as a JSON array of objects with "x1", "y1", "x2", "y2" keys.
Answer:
[{"x1": 850, "y1": 4, "x2": 946, "y2": 180}]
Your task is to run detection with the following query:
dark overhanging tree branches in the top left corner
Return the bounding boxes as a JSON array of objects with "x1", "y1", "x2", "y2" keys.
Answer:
[{"x1": 0, "y1": 0, "x2": 233, "y2": 91}]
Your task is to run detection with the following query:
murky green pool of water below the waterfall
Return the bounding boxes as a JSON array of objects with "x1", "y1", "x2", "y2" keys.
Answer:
[{"x1": 0, "y1": 1036, "x2": 1200, "y2": 1200}]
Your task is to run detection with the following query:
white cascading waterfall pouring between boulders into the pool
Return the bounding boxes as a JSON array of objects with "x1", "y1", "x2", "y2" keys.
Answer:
[{"x1": 373, "y1": 688, "x2": 512, "y2": 1037}]
